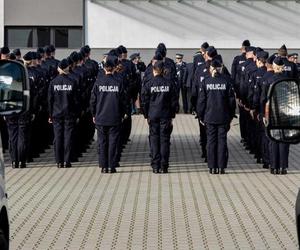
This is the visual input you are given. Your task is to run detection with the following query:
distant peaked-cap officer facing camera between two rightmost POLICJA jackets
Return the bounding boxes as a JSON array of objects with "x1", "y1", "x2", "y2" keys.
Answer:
[{"x1": 176, "y1": 53, "x2": 189, "y2": 114}]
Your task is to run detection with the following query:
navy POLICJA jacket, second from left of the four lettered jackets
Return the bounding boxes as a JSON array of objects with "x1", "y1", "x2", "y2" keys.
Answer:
[{"x1": 90, "y1": 75, "x2": 127, "y2": 126}]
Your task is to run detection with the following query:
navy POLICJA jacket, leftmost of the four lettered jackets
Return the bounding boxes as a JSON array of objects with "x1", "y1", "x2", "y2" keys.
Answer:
[{"x1": 48, "y1": 74, "x2": 79, "y2": 118}]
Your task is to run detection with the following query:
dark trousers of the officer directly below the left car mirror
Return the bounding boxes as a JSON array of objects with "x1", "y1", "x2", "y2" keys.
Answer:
[{"x1": 6, "y1": 118, "x2": 30, "y2": 163}]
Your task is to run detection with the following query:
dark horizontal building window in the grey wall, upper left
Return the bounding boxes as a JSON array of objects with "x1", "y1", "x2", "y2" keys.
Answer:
[{"x1": 5, "y1": 26, "x2": 83, "y2": 49}]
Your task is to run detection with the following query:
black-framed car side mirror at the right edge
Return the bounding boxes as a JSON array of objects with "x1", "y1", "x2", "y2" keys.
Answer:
[{"x1": 265, "y1": 79, "x2": 300, "y2": 144}]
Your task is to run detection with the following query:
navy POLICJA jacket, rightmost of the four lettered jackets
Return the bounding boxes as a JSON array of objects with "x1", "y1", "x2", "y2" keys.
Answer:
[{"x1": 197, "y1": 75, "x2": 236, "y2": 124}]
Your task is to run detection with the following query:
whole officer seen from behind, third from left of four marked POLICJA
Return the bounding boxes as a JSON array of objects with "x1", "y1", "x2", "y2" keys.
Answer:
[{"x1": 142, "y1": 61, "x2": 178, "y2": 174}]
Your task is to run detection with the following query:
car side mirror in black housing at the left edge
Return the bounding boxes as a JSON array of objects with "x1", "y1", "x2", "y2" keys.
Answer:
[{"x1": 0, "y1": 60, "x2": 30, "y2": 115}]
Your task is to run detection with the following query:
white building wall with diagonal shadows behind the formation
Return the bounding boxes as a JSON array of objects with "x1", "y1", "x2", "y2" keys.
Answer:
[{"x1": 86, "y1": 0, "x2": 300, "y2": 49}]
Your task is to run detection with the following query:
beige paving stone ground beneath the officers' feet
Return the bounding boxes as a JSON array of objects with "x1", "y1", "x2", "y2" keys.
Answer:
[{"x1": 6, "y1": 115, "x2": 300, "y2": 250}]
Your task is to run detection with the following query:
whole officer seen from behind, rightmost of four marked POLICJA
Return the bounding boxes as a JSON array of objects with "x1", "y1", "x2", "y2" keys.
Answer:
[{"x1": 197, "y1": 60, "x2": 236, "y2": 174}]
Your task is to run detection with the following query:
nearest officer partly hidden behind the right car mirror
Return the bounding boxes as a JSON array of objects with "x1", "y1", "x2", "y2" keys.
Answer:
[{"x1": 262, "y1": 56, "x2": 290, "y2": 175}]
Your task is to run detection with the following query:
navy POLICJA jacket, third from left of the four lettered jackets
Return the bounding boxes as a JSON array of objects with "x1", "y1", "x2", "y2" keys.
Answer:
[{"x1": 142, "y1": 76, "x2": 178, "y2": 120}]
